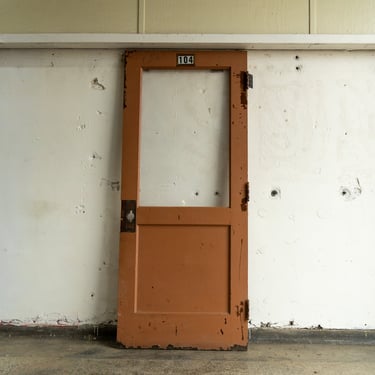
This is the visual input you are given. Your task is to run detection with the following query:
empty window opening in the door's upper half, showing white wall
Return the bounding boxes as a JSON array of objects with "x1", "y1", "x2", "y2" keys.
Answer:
[{"x1": 139, "y1": 70, "x2": 229, "y2": 207}]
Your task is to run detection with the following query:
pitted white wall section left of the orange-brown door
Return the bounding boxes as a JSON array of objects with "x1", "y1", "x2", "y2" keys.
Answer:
[{"x1": 0, "y1": 50, "x2": 123, "y2": 325}]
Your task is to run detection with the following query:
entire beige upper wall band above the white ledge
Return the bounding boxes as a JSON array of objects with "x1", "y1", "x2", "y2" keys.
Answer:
[{"x1": 0, "y1": 0, "x2": 375, "y2": 34}]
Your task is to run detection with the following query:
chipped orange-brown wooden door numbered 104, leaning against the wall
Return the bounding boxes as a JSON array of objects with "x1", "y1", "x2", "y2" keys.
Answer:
[{"x1": 117, "y1": 51, "x2": 248, "y2": 350}]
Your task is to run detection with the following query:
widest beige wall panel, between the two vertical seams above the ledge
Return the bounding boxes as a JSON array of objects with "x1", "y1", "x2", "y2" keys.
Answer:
[{"x1": 145, "y1": 0, "x2": 309, "y2": 34}]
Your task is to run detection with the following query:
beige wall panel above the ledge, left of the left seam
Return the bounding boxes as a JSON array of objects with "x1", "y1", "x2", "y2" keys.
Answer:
[{"x1": 0, "y1": 0, "x2": 138, "y2": 33}]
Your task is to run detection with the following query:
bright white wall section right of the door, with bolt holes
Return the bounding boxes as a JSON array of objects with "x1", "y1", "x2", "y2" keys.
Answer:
[{"x1": 249, "y1": 51, "x2": 375, "y2": 328}]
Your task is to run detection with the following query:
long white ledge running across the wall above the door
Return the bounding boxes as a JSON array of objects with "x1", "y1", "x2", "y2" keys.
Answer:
[{"x1": 0, "y1": 33, "x2": 375, "y2": 50}]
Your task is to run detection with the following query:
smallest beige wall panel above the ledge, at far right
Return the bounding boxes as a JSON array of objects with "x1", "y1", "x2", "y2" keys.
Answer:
[{"x1": 311, "y1": 0, "x2": 375, "y2": 34}]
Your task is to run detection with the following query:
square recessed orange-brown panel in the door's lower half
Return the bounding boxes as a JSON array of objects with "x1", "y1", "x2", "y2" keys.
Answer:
[{"x1": 136, "y1": 225, "x2": 230, "y2": 313}]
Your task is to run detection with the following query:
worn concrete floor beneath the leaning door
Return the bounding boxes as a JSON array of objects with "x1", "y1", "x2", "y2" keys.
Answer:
[{"x1": 0, "y1": 336, "x2": 375, "y2": 375}]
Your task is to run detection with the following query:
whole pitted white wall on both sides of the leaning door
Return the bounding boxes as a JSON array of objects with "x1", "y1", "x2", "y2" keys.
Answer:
[{"x1": 0, "y1": 50, "x2": 375, "y2": 328}]
